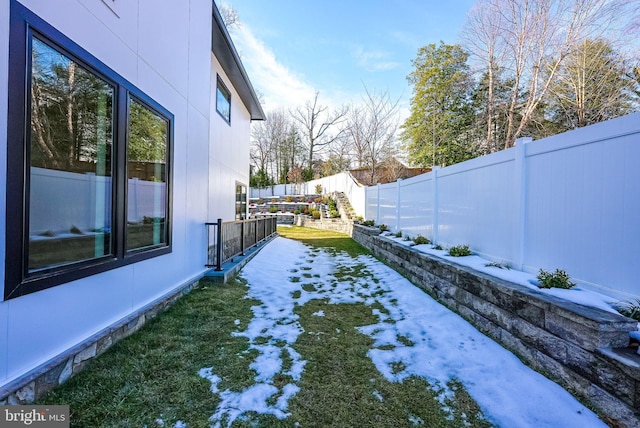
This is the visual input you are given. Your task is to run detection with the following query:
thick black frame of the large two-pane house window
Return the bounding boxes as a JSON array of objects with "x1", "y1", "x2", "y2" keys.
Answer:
[{"x1": 4, "y1": 0, "x2": 175, "y2": 300}]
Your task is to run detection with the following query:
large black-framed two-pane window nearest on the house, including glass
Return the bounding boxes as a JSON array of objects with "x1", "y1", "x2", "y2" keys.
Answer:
[{"x1": 4, "y1": 1, "x2": 173, "y2": 299}]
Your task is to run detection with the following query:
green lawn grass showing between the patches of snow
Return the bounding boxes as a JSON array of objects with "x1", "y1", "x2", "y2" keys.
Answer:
[{"x1": 39, "y1": 227, "x2": 490, "y2": 428}]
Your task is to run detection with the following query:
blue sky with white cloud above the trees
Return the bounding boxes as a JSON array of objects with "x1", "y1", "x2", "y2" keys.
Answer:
[{"x1": 221, "y1": 0, "x2": 475, "y2": 114}]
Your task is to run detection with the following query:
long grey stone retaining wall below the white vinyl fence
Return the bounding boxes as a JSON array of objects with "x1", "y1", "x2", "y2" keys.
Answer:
[{"x1": 352, "y1": 225, "x2": 640, "y2": 427}]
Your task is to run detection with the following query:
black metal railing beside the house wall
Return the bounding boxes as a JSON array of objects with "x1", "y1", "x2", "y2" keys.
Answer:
[{"x1": 205, "y1": 216, "x2": 277, "y2": 271}]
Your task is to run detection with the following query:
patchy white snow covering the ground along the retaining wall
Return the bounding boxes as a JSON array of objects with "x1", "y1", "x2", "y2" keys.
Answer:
[{"x1": 194, "y1": 237, "x2": 606, "y2": 428}]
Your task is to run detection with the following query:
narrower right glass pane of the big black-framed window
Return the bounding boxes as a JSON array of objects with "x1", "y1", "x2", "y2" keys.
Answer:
[{"x1": 127, "y1": 99, "x2": 168, "y2": 250}]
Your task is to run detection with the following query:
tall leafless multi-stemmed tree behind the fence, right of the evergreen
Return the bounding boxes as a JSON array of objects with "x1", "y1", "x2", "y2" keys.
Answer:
[{"x1": 466, "y1": 0, "x2": 627, "y2": 148}]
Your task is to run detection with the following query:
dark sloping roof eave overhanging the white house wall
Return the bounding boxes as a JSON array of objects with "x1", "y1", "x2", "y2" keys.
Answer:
[{"x1": 211, "y1": 2, "x2": 265, "y2": 120}]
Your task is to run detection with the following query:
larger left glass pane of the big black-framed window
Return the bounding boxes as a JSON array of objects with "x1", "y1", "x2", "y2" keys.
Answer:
[{"x1": 27, "y1": 38, "x2": 114, "y2": 272}]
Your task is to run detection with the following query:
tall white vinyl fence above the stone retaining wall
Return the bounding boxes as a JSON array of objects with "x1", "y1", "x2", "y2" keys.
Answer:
[{"x1": 365, "y1": 113, "x2": 640, "y2": 298}]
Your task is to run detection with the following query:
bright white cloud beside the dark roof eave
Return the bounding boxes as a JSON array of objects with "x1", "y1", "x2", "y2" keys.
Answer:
[{"x1": 232, "y1": 23, "x2": 315, "y2": 111}]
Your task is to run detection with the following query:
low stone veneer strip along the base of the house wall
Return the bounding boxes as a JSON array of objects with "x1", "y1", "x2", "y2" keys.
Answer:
[{"x1": 0, "y1": 279, "x2": 199, "y2": 405}]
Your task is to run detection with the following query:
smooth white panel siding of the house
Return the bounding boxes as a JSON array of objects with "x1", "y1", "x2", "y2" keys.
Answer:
[{"x1": 0, "y1": 0, "x2": 255, "y2": 387}]
